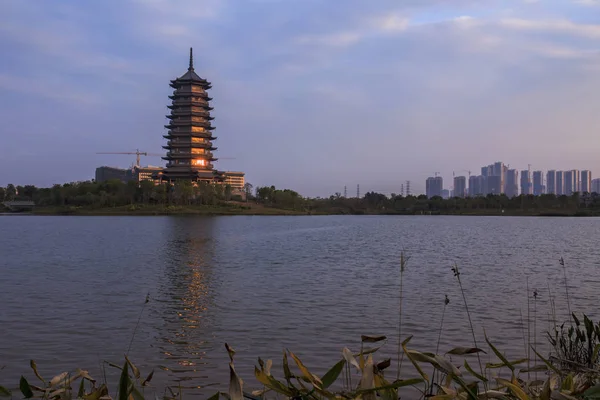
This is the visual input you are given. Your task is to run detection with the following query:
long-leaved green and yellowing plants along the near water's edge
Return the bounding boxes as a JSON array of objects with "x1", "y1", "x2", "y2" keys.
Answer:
[{"x1": 0, "y1": 253, "x2": 600, "y2": 400}]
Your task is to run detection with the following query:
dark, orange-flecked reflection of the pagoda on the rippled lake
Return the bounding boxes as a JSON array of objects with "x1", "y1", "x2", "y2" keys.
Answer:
[{"x1": 154, "y1": 218, "x2": 218, "y2": 389}]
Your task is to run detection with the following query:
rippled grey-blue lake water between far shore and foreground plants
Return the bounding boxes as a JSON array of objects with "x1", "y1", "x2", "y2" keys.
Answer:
[{"x1": 0, "y1": 216, "x2": 600, "y2": 395}]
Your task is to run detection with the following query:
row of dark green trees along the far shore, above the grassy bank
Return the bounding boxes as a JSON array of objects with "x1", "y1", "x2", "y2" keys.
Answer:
[{"x1": 0, "y1": 180, "x2": 600, "y2": 214}]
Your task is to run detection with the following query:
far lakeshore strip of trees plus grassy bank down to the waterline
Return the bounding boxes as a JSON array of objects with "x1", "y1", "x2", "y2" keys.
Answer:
[{"x1": 0, "y1": 180, "x2": 600, "y2": 216}]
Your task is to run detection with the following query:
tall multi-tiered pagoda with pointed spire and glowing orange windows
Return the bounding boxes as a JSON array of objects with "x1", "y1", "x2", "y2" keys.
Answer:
[{"x1": 162, "y1": 48, "x2": 224, "y2": 182}]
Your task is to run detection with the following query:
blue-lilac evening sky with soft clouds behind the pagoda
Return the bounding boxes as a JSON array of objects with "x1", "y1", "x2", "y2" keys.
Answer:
[{"x1": 0, "y1": 0, "x2": 600, "y2": 196}]
